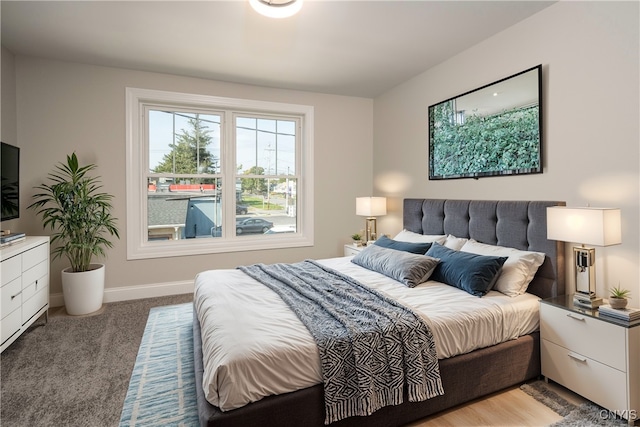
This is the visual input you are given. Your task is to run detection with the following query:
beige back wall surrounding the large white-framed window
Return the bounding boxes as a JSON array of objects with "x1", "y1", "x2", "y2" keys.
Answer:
[{"x1": 3, "y1": 55, "x2": 373, "y2": 303}]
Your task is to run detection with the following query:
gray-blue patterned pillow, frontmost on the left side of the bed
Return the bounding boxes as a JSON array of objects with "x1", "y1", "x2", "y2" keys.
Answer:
[{"x1": 351, "y1": 245, "x2": 438, "y2": 288}]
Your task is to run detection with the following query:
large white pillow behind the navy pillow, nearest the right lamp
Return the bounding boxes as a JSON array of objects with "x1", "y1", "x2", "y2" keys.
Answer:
[{"x1": 460, "y1": 239, "x2": 545, "y2": 297}]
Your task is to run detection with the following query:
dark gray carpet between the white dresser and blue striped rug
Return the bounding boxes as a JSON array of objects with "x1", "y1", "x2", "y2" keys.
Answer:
[{"x1": 0, "y1": 294, "x2": 192, "y2": 427}]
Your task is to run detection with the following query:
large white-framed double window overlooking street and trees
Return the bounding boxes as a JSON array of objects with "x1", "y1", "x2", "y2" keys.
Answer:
[{"x1": 126, "y1": 88, "x2": 313, "y2": 259}]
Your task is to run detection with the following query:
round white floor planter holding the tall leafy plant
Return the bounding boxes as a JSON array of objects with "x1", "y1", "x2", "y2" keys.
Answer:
[{"x1": 62, "y1": 264, "x2": 105, "y2": 316}]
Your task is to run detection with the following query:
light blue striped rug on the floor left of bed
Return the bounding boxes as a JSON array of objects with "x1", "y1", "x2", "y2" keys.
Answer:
[{"x1": 120, "y1": 303, "x2": 198, "y2": 427}]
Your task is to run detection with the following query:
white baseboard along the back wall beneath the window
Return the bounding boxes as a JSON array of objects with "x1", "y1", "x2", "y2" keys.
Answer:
[{"x1": 49, "y1": 280, "x2": 193, "y2": 307}]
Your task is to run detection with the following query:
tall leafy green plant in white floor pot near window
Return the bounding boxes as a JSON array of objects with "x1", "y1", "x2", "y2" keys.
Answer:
[{"x1": 28, "y1": 153, "x2": 120, "y2": 315}]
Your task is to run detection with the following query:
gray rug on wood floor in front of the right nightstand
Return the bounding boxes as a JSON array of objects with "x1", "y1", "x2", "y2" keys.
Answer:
[{"x1": 520, "y1": 381, "x2": 628, "y2": 427}]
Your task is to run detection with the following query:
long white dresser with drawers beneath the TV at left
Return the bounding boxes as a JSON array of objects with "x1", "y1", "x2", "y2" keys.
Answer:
[{"x1": 0, "y1": 236, "x2": 49, "y2": 352}]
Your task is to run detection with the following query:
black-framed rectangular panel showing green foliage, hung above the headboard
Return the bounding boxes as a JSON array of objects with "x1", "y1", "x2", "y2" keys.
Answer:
[{"x1": 429, "y1": 65, "x2": 542, "y2": 180}]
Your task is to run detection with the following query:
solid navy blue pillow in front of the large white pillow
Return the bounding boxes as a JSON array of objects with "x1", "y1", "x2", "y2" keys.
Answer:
[{"x1": 425, "y1": 243, "x2": 508, "y2": 297}]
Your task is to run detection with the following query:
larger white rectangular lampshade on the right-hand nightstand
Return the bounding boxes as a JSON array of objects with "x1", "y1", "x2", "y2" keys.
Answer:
[{"x1": 547, "y1": 206, "x2": 622, "y2": 246}]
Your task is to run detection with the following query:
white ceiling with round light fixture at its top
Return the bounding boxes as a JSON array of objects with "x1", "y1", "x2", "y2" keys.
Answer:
[{"x1": 0, "y1": 0, "x2": 554, "y2": 98}]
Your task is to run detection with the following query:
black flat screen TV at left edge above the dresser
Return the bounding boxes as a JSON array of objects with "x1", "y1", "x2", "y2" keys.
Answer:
[{"x1": 0, "y1": 142, "x2": 20, "y2": 221}]
